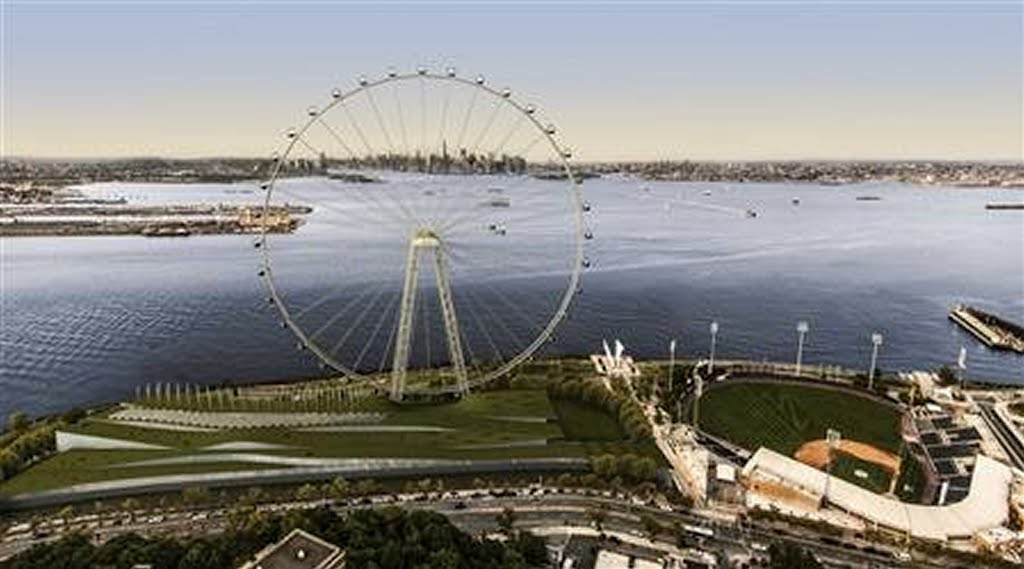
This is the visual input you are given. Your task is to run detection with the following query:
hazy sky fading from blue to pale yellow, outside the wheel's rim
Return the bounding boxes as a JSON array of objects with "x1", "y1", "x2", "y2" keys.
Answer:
[{"x1": 0, "y1": 0, "x2": 1024, "y2": 161}]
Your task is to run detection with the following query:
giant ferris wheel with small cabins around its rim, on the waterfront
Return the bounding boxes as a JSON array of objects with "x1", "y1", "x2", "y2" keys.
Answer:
[{"x1": 255, "y1": 68, "x2": 592, "y2": 400}]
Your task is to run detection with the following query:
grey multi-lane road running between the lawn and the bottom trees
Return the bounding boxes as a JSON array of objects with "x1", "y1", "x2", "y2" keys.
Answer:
[{"x1": 0, "y1": 488, "x2": 951, "y2": 568}]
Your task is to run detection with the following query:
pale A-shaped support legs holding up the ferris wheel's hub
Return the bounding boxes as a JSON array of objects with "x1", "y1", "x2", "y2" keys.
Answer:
[{"x1": 391, "y1": 227, "x2": 469, "y2": 401}]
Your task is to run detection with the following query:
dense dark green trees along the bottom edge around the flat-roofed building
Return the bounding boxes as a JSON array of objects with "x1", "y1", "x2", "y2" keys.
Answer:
[{"x1": 0, "y1": 508, "x2": 548, "y2": 569}]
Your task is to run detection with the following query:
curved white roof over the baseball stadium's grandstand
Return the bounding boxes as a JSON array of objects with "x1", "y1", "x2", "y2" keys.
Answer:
[{"x1": 743, "y1": 447, "x2": 1013, "y2": 540}]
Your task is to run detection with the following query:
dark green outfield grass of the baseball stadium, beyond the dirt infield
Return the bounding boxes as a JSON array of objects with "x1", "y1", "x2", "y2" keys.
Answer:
[{"x1": 700, "y1": 383, "x2": 901, "y2": 456}]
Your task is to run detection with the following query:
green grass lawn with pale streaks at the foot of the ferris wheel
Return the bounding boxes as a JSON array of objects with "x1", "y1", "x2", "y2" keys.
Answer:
[{"x1": 0, "y1": 390, "x2": 658, "y2": 495}]
